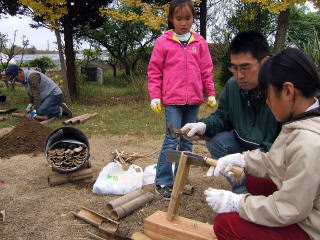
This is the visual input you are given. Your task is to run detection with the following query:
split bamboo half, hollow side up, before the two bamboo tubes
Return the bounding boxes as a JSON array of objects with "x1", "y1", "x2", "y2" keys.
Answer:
[{"x1": 71, "y1": 207, "x2": 119, "y2": 233}]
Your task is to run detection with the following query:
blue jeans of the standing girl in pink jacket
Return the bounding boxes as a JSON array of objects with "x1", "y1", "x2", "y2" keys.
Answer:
[{"x1": 155, "y1": 105, "x2": 199, "y2": 186}]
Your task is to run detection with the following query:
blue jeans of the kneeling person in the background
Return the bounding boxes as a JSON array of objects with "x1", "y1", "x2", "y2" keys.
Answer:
[{"x1": 37, "y1": 94, "x2": 63, "y2": 118}]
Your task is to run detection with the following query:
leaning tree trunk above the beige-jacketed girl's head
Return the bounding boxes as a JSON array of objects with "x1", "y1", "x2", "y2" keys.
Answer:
[{"x1": 274, "y1": 8, "x2": 290, "y2": 53}]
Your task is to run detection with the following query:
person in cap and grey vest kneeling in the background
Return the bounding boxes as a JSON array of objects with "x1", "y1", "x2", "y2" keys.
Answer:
[{"x1": 6, "y1": 65, "x2": 72, "y2": 118}]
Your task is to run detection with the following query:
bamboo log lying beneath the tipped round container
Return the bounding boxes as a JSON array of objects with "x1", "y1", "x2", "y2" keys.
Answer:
[{"x1": 48, "y1": 168, "x2": 93, "y2": 187}]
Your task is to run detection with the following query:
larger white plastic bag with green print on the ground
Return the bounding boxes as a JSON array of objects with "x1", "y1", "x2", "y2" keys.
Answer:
[{"x1": 92, "y1": 162, "x2": 143, "y2": 195}]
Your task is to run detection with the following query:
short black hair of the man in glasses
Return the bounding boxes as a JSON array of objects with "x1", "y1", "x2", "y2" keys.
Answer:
[{"x1": 229, "y1": 31, "x2": 270, "y2": 61}]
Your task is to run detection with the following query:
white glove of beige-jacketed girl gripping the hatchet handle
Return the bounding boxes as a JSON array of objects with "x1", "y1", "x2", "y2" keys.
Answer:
[{"x1": 214, "y1": 153, "x2": 246, "y2": 177}]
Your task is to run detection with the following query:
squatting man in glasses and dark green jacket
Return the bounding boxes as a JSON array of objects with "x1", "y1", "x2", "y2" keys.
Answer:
[{"x1": 182, "y1": 31, "x2": 280, "y2": 193}]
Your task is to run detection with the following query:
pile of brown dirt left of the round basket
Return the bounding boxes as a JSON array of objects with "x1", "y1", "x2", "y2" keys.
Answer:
[{"x1": 0, "y1": 119, "x2": 52, "y2": 158}]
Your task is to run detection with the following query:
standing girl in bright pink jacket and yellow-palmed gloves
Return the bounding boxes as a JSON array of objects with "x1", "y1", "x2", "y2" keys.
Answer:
[{"x1": 148, "y1": 0, "x2": 216, "y2": 200}]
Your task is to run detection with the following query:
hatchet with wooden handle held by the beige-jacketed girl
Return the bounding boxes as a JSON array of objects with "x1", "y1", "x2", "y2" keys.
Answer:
[{"x1": 167, "y1": 150, "x2": 244, "y2": 180}]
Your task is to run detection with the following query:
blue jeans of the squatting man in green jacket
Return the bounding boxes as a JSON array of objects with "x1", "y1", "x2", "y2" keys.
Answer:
[{"x1": 206, "y1": 131, "x2": 249, "y2": 194}]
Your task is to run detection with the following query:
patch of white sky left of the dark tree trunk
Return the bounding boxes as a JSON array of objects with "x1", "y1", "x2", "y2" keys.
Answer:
[{"x1": 0, "y1": 16, "x2": 57, "y2": 50}]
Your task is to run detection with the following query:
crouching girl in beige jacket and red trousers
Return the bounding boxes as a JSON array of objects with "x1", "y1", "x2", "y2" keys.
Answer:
[{"x1": 205, "y1": 48, "x2": 320, "y2": 240}]
